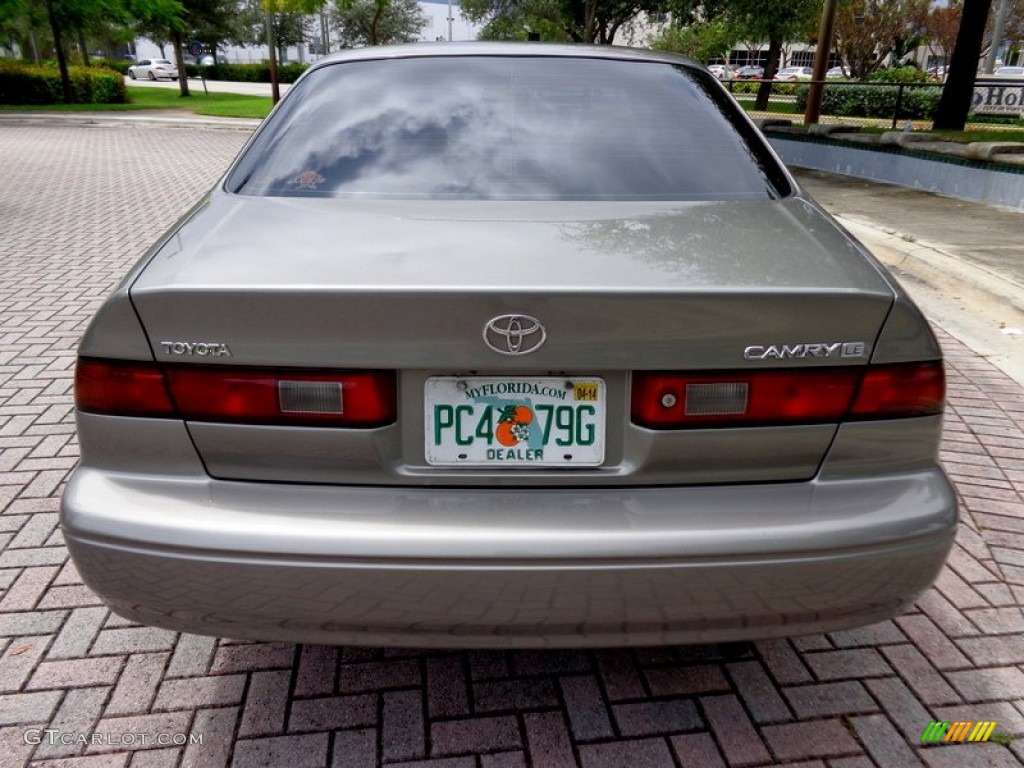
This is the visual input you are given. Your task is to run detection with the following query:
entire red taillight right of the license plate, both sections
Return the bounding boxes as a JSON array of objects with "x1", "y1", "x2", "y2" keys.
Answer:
[{"x1": 632, "y1": 362, "x2": 945, "y2": 429}]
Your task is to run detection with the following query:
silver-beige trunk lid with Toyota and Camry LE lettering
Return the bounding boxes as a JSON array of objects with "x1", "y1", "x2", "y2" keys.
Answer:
[{"x1": 131, "y1": 195, "x2": 893, "y2": 485}]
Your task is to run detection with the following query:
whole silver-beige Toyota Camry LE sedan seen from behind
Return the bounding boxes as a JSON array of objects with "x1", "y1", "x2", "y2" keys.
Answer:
[{"x1": 61, "y1": 44, "x2": 957, "y2": 647}]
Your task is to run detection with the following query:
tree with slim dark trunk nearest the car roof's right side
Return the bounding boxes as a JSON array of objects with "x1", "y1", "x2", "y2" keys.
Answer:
[{"x1": 726, "y1": 0, "x2": 821, "y2": 110}]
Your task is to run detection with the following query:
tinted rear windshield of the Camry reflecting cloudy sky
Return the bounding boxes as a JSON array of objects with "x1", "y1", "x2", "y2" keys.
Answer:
[{"x1": 227, "y1": 56, "x2": 788, "y2": 201}]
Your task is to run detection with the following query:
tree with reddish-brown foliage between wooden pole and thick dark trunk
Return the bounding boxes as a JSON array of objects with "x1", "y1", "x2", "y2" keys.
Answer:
[{"x1": 836, "y1": 0, "x2": 930, "y2": 79}]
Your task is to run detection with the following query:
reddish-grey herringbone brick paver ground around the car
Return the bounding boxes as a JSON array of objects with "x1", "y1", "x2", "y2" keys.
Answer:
[{"x1": 0, "y1": 125, "x2": 1024, "y2": 768}]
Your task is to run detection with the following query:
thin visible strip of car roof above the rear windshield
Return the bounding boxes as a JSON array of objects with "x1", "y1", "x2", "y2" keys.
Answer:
[{"x1": 309, "y1": 41, "x2": 703, "y2": 71}]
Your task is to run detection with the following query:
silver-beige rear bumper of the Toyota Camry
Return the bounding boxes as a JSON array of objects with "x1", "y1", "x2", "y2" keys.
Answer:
[{"x1": 61, "y1": 468, "x2": 956, "y2": 647}]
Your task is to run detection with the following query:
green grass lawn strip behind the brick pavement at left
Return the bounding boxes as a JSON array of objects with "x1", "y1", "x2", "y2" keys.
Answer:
[{"x1": 0, "y1": 81, "x2": 272, "y2": 119}]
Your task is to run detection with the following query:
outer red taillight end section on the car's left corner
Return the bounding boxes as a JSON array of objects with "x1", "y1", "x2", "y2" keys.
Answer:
[{"x1": 75, "y1": 359, "x2": 174, "y2": 417}]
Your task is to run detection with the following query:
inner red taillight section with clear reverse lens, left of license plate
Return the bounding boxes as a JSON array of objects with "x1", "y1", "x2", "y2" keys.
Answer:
[{"x1": 167, "y1": 367, "x2": 396, "y2": 427}]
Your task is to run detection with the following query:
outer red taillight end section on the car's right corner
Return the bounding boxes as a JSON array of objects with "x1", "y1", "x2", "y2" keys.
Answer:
[{"x1": 851, "y1": 361, "x2": 946, "y2": 419}]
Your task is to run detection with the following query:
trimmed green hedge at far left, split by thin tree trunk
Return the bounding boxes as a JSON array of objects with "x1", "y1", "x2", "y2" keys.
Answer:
[{"x1": 0, "y1": 61, "x2": 128, "y2": 104}]
